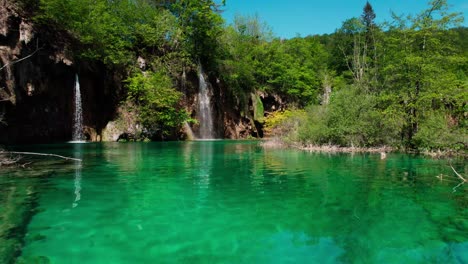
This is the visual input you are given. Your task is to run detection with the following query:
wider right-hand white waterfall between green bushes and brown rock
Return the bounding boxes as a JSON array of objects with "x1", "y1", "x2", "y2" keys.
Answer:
[{"x1": 198, "y1": 66, "x2": 214, "y2": 139}]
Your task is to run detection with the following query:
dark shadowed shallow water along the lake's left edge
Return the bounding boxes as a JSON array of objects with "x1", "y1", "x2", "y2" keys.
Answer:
[{"x1": 0, "y1": 146, "x2": 87, "y2": 263}]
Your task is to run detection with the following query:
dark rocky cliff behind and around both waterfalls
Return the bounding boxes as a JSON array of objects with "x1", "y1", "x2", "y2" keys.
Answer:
[{"x1": 0, "y1": 0, "x2": 280, "y2": 144}]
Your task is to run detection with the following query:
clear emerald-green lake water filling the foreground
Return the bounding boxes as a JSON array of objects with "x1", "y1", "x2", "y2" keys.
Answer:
[{"x1": 0, "y1": 141, "x2": 468, "y2": 263}]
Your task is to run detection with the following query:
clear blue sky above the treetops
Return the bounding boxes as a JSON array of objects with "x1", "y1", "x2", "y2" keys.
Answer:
[{"x1": 223, "y1": 0, "x2": 468, "y2": 38}]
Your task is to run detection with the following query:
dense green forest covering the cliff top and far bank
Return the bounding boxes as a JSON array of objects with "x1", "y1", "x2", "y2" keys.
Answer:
[{"x1": 5, "y1": 0, "x2": 468, "y2": 151}]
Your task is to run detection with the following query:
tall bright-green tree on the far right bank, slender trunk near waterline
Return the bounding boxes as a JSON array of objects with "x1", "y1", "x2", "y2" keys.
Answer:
[{"x1": 385, "y1": 0, "x2": 466, "y2": 148}]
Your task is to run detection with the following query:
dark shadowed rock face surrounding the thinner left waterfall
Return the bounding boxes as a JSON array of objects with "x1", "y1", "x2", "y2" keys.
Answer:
[{"x1": 0, "y1": 0, "x2": 120, "y2": 144}]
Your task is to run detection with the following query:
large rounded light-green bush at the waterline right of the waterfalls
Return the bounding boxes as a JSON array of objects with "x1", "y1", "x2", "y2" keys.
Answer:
[{"x1": 278, "y1": 87, "x2": 400, "y2": 147}]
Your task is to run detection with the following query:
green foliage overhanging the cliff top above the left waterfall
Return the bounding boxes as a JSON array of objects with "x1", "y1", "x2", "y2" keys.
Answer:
[{"x1": 35, "y1": 0, "x2": 181, "y2": 65}]
